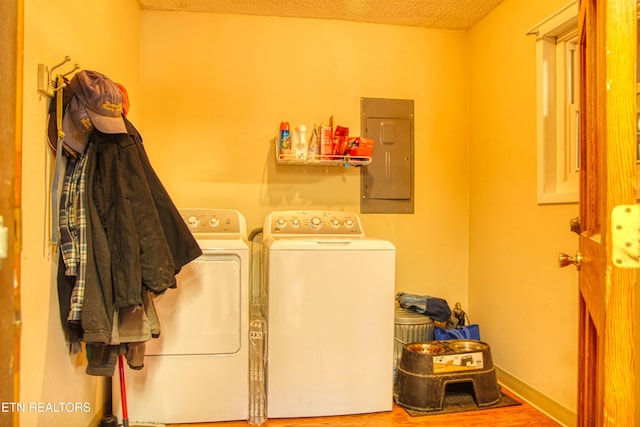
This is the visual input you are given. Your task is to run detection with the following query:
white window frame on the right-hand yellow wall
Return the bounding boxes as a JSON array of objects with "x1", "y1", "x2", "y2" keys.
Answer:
[{"x1": 527, "y1": 1, "x2": 579, "y2": 204}]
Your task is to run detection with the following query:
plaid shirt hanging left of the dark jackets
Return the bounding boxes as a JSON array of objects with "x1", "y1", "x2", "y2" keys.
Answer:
[{"x1": 59, "y1": 151, "x2": 87, "y2": 322}]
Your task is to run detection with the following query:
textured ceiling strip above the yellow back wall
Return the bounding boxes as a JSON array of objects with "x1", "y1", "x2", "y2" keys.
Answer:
[{"x1": 138, "y1": 0, "x2": 504, "y2": 30}]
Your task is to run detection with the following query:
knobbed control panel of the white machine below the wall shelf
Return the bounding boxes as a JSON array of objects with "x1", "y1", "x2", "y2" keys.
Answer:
[{"x1": 264, "y1": 211, "x2": 365, "y2": 237}]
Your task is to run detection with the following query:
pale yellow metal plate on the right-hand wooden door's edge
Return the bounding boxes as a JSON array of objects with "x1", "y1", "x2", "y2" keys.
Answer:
[{"x1": 611, "y1": 205, "x2": 640, "y2": 268}]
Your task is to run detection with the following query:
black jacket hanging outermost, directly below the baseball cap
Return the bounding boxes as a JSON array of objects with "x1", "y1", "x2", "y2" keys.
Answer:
[{"x1": 92, "y1": 119, "x2": 202, "y2": 307}]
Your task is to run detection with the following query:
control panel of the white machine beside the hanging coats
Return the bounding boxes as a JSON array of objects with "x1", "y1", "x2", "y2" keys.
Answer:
[{"x1": 180, "y1": 209, "x2": 247, "y2": 237}]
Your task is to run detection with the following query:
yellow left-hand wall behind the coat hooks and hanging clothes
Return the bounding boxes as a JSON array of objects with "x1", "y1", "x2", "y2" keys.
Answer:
[{"x1": 20, "y1": 0, "x2": 140, "y2": 427}]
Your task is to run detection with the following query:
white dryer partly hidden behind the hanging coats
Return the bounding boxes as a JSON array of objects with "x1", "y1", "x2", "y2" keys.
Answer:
[{"x1": 112, "y1": 209, "x2": 249, "y2": 424}]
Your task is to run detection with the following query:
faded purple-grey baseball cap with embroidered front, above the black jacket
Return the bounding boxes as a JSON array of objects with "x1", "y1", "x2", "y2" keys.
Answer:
[{"x1": 69, "y1": 70, "x2": 127, "y2": 133}]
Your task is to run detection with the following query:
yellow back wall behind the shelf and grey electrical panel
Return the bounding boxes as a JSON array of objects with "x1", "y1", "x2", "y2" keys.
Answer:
[{"x1": 140, "y1": 11, "x2": 468, "y2": 303}]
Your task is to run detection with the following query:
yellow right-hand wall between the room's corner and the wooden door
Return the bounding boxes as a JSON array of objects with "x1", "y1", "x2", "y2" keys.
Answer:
[{"x1": 469, "y1": 0, "x2": 578, "y2": 422}]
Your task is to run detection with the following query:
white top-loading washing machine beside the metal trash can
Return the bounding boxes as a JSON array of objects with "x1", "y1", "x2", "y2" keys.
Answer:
[{"x1": 263, "y1": 211, "x2": 396, "y2": 418}]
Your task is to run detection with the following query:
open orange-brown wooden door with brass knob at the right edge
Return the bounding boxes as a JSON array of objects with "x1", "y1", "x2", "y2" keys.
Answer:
[{"x1": 578, "y1": 0, "x2": 640, "y2": 426}]
